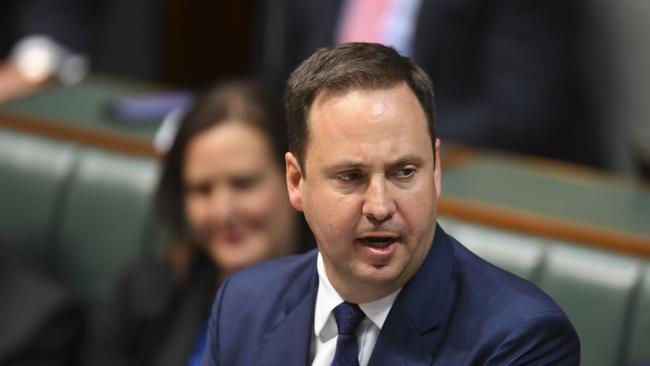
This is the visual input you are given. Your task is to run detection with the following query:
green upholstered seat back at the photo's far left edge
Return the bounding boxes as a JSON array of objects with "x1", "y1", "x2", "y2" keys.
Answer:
[{"x1": 0, "y1": 129, "x2": 78, "y2": 265}]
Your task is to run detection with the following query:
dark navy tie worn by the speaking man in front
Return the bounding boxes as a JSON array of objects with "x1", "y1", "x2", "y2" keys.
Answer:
[{"x1": 332, "y1": 302, "x2": 365, "y2": 366}]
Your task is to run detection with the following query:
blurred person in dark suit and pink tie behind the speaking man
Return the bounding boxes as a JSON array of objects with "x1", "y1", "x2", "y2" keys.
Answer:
[{"x1": 255, "y1": 0, "x2": 604, "y2": 166}]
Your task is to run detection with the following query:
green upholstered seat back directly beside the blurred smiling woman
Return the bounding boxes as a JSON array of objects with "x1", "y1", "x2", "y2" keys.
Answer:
[{"x1": 51, "y1": 149, "x2": 158, "y2": 310}]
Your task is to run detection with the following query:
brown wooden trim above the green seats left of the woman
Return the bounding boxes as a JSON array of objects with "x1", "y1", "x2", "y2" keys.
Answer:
[{"x1": 0, "y1": 111, "x2": 159, "y2": 157}]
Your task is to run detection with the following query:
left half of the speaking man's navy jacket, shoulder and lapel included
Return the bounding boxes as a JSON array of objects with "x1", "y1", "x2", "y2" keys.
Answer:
[{"x1": 201, "y1": 250, "x2": 318, "y2": 365}]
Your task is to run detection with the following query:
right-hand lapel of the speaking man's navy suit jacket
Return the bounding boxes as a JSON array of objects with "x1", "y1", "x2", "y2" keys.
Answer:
[{"x1": 368, "y1": 226, "x2": 453, "y2": 366}]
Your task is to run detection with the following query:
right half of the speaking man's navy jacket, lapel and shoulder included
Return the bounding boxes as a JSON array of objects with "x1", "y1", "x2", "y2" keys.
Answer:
[{"x1": 378, "y1": 228, "x2": 580, "y2": 365}]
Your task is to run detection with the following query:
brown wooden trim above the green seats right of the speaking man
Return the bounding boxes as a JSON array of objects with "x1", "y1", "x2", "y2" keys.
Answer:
[{"x1": 438, "y1": 197, "x2": 650, "y2": 258}]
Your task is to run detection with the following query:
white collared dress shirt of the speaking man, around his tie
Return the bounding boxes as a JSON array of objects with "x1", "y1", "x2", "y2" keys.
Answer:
[{"x1": 310, "y1": 253, "x2": 401, "y2": 366}]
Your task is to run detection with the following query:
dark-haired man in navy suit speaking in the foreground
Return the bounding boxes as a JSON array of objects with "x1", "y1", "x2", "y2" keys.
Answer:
[{"x1": 202, "y1": 43, "x2": 580, "y2": 366}]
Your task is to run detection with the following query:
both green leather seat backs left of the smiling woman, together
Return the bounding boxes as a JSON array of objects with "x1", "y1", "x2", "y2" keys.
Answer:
[{"x1": 0, "y1": 128, "x2": 159, "y2": 314}]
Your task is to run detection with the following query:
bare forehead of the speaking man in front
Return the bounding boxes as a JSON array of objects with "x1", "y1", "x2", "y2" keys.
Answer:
[{"x1": 305, "y1": 83, "x2": 431, "y2": 165}]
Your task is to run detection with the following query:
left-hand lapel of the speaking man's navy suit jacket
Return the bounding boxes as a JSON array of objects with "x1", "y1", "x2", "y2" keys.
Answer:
[{"x1": 261, "y1": 256, "x2": 318, "y2": 366}]
